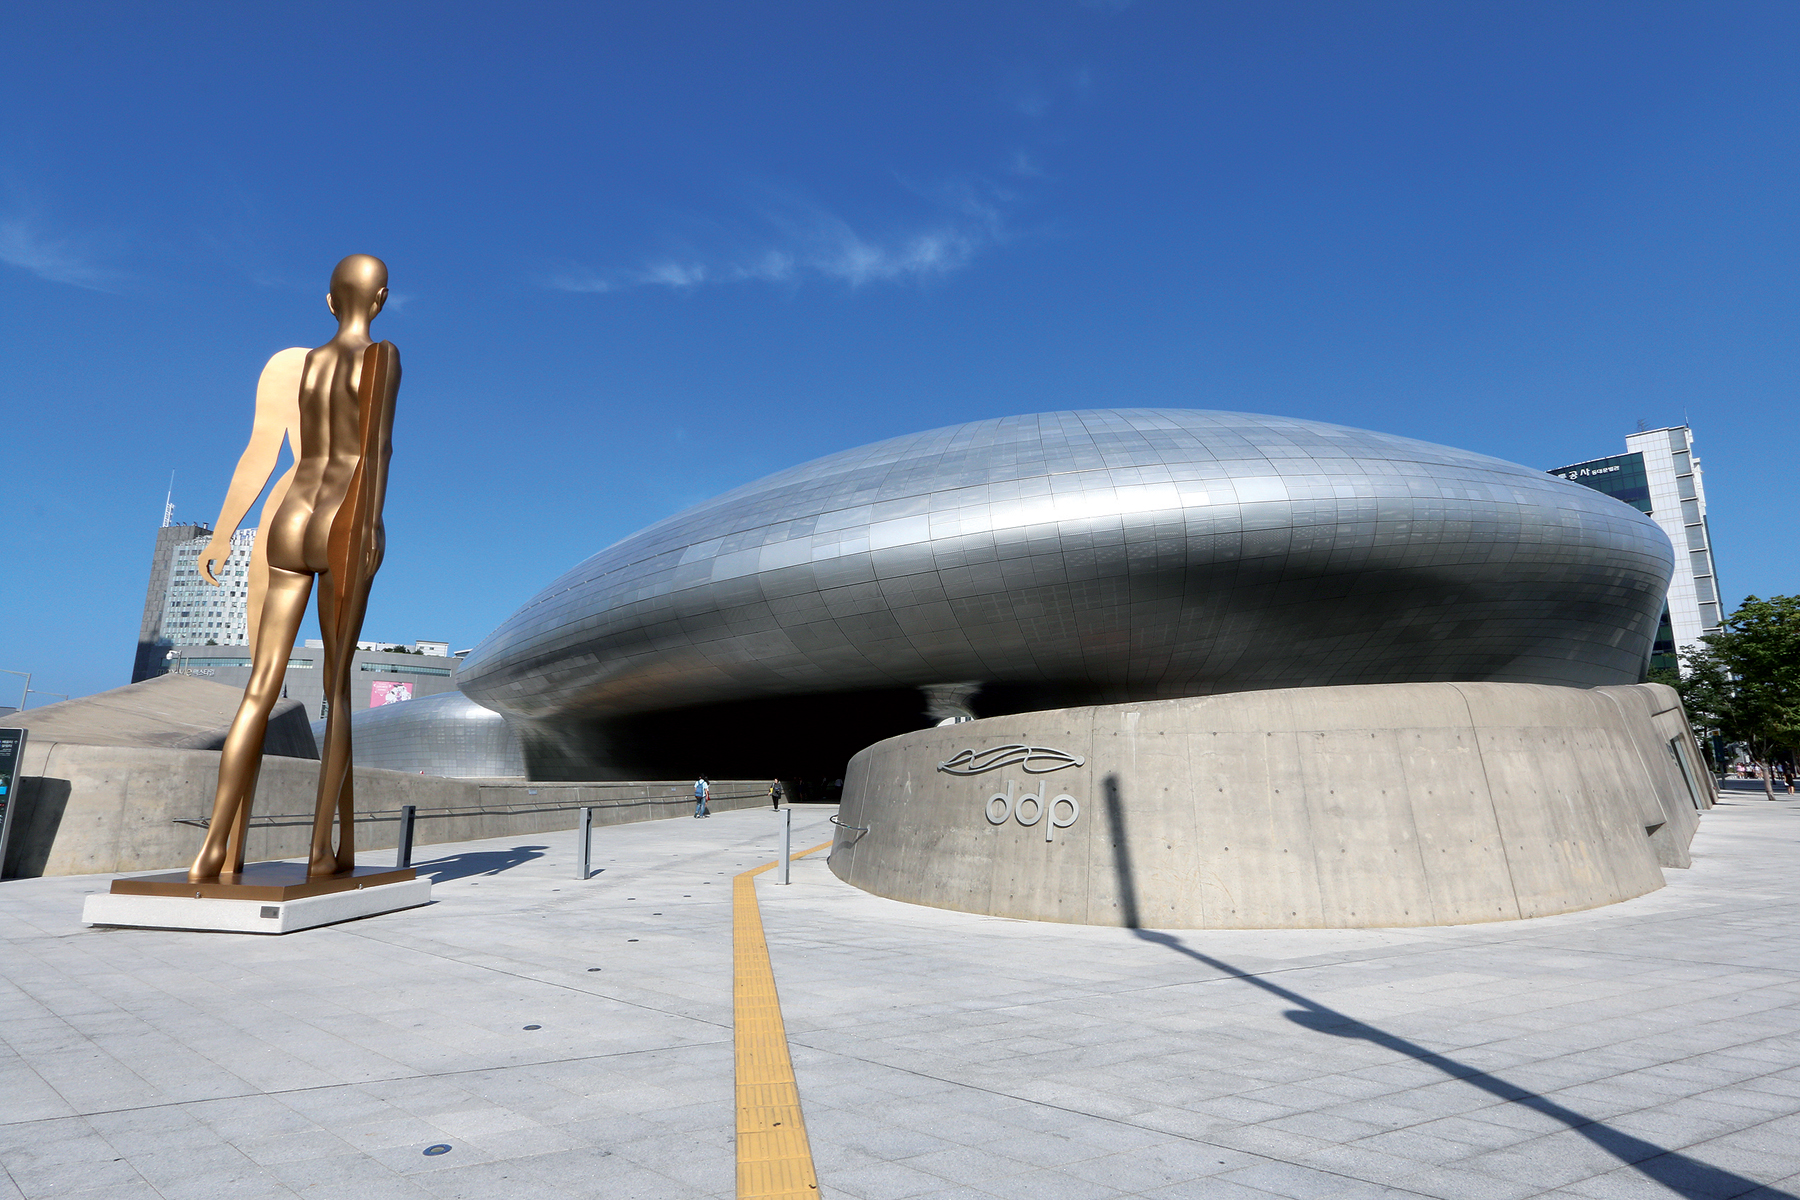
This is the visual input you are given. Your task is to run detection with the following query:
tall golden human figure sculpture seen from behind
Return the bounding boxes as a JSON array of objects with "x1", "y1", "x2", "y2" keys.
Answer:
[{"x1": 176, "y1": 254, "x2": 400, "y2": 883}]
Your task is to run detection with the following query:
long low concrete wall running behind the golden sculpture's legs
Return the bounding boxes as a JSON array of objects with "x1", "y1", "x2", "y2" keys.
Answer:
[{"x1": 0, "y1": 743, "x2": 769, "y2": 880}]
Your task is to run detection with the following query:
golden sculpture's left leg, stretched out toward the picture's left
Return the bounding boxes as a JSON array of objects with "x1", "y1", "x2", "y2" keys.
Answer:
[{"x1": 187, "y1": 567, "x2": 313, "y2": 883}]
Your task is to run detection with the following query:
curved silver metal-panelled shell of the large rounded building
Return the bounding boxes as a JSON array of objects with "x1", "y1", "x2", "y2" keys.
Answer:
[{"x1": 459, "y1": 408, "x2": 1672, "y2": 720}]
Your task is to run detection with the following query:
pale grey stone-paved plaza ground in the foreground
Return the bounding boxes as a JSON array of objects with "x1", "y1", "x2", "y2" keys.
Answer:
[{"x1": 0, "y1": 790, "x2": 1800, "y2": 1200}]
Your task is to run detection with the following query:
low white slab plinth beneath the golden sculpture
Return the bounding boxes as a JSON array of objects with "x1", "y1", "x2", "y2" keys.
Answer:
[{"x1": 81, "y1": 877, "x2": 432, "y2": 934}]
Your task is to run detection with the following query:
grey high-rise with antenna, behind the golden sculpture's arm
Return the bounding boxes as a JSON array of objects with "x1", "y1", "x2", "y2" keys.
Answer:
[{"x1": 131, "y1": 525, "x2": 256, "y2": 684}]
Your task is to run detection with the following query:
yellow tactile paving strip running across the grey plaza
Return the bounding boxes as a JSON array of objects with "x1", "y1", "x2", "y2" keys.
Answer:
[{"x1": 731, "y1": 842, "x2": 830, "y2": 1200}]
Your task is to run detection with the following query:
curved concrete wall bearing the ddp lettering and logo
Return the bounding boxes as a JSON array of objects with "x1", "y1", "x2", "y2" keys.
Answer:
[{"x1": 830, "y1": 684, "x2": 1712, "y2": 928}]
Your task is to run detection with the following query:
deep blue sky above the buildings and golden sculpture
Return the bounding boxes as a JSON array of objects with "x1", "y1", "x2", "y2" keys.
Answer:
[{"x1": 0, "y1": 0, "x2": 1800, "y2": 703}]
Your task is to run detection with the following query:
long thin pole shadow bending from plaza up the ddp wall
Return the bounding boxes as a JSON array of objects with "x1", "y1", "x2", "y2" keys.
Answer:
[{"x1": 1103, "y1": 774, "x2": 1796, "y2": 1200}]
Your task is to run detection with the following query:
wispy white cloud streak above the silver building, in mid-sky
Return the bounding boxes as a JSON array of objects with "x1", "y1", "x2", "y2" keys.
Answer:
[{"x1": 542, "y1": 182, "x2": 1006, "y2": 293}]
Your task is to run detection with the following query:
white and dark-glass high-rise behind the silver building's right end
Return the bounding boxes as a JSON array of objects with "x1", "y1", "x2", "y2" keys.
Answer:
[{"x1": 1550, "y1": 425, "x2": 1723, "y2": 667}]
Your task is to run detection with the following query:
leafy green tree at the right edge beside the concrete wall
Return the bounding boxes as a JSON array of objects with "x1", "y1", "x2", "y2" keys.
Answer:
[{"x1": 1676, "y1": 596, "x2": 1800, "y2": 801}]
